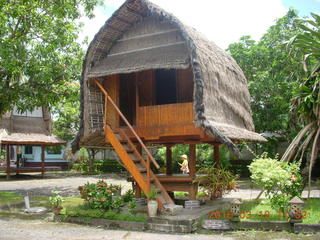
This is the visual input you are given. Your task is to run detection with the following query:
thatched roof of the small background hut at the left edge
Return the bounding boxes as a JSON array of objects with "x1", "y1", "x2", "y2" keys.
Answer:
[{"x1": 0, "y1": 108, "x2": 66, "y2": 145}]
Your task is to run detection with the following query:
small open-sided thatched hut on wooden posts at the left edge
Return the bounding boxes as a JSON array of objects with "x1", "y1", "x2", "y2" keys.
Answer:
[{"x1": 0, "y1": 107, "x2": 66, "y2": 179}]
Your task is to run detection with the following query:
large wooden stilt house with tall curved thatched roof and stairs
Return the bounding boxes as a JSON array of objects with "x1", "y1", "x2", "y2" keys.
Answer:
[{"x1": 74, "y1": 0, "x2": 265, "y2": 204}]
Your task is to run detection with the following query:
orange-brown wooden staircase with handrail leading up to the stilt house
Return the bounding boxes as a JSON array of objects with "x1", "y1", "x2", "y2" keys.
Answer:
[{"x1": 95, "y1": 80, "x2": 174, "y2": 208}]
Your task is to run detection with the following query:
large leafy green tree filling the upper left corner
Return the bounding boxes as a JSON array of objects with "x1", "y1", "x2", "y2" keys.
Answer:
[{"x1": 0, "y1": 0, "x2": 101, "y2": 116}]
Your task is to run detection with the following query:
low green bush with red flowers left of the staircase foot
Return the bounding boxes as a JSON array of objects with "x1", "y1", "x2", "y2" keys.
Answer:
[{"x1": 78, "y1": 180, "x2": 123, "y2": 210}]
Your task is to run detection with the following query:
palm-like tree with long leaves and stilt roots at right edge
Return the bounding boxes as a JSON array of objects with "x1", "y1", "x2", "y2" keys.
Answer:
[{"x1": 281, "y1": 14, "x2": 320, "y2": 196}]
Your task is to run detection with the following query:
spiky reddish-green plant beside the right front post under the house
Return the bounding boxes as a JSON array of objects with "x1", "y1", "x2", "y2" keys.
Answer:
[{"x1": 195, "y1": 167, "x2": 239, "y2": 199}]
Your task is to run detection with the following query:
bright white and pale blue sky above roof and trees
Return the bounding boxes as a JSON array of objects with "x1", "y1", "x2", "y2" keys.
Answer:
[{"x1": 80, "y1": 0, "x2": 320, "y2": 49}]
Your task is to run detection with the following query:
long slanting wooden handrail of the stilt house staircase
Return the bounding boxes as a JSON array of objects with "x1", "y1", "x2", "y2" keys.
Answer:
[{"x1": 95, "y1": 79, "x2": 160, "y2": 169}]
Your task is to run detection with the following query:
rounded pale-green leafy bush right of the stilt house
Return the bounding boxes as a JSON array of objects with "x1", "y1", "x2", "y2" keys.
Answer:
[{"x1": 249, "y1": 153, "x2": 303, "y2": 211}]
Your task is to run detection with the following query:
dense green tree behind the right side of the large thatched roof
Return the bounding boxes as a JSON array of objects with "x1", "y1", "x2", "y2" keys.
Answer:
[{"x1": 227, "y1": 10, "x2": 302, "y2": 133}]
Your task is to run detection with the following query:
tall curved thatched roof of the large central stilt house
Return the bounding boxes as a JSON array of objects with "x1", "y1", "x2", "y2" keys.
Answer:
[{"x1": 75, "y1": 0, "x2": 265, "y2": 155}]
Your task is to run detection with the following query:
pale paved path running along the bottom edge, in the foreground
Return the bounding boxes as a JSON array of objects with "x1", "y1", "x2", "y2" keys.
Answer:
[{"x1": 0, "y1": 219, "x2": 236, "y2": 240}]
